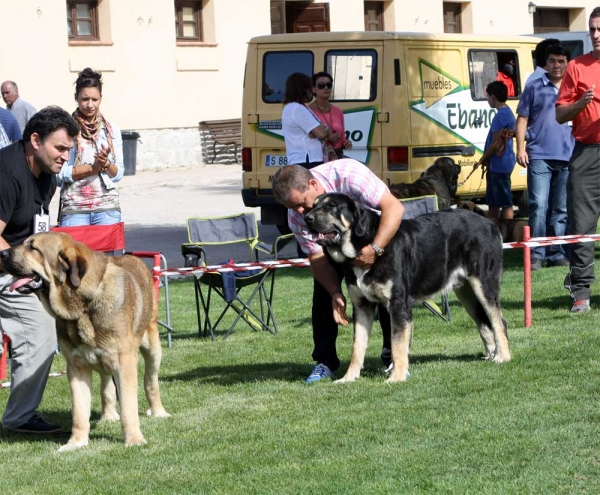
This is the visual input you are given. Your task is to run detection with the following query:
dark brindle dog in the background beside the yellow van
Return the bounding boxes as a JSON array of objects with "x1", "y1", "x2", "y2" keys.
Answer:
[{"x1": 390, "y1": 156, "x2": 461, "y2": 210}]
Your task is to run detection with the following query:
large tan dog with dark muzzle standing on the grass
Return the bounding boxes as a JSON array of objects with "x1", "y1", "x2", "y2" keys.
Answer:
[{"x1": 0, "y1": 233, "x2": 169, "y2": 451}]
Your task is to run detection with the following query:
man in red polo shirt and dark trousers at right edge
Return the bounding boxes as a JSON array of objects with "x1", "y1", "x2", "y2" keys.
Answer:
[{"x1": 556, "y1": 7, "x2": 600, "y2": 313}]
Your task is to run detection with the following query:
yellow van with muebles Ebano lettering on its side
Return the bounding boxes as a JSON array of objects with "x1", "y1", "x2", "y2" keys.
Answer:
[{"x1": 242, "y1": 32, "x2": 540, "y2": 230}]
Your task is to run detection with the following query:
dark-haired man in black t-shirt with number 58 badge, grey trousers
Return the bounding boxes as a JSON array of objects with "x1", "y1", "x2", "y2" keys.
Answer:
[{"x1": 0, "y1": 107, "x2": 79, "y2": 433}]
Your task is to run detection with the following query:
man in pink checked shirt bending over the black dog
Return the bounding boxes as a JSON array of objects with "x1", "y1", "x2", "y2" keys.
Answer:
[{"x1": 273, "y1": 159, "x2": 404, "y2": 383}]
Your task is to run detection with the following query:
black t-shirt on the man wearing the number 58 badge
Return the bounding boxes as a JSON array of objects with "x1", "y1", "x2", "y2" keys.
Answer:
[{"x1": 0, "y1": 141, "x2": 56, "y2": 246}]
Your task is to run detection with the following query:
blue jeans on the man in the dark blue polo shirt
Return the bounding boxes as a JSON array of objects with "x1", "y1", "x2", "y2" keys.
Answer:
[{"x1": 527, "y1": 159, "x2": 569, "y2": 262}]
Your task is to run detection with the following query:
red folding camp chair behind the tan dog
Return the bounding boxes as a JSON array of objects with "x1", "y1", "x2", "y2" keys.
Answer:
[{"x1": 50, "y1": 222, "x2": 173, "y2": 347}]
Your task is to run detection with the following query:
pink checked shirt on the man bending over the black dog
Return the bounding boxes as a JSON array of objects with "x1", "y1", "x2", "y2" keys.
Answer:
[{"x1": 288, "y1": 158, "x2": 388, "y2": 254}]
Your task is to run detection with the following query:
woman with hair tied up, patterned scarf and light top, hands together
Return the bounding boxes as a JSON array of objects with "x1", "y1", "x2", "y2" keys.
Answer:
[{"x1": 58, "y1": 68, "x2": 125, "y2": 227}]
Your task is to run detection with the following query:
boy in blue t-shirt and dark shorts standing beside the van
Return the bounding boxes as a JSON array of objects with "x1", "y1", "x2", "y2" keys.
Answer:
[{"x1": 484, "y1": 81, "x2": 516, "y2": 224}]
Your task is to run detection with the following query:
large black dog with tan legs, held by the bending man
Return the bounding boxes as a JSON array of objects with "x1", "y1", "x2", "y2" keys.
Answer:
[{"x1": 304, "y1": 193, "x2": 510, "y2": 382}]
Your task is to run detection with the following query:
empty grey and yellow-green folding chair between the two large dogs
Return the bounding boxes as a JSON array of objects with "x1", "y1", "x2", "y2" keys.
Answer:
[{"x1": 181, "y1": 213, "x2": 294, "y2": 340}]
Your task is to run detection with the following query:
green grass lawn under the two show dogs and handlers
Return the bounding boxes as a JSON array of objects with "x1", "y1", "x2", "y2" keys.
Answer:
[{"x1": 0, "y1": 250, "x2": 600, "y2": 494}]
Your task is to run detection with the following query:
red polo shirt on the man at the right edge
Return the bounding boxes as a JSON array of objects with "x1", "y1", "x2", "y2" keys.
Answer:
[{"x1": 556, "y1": 53, "x2": 600, "y2": 144}]
